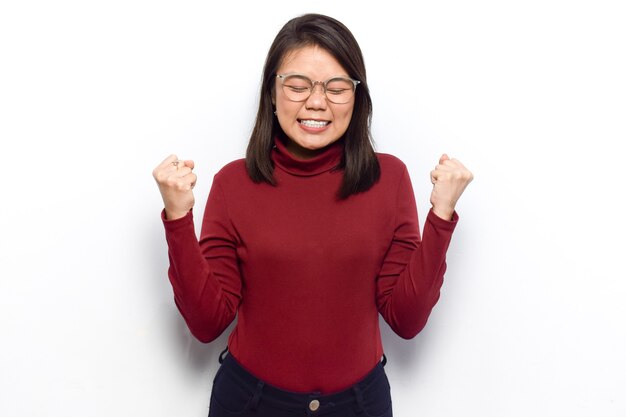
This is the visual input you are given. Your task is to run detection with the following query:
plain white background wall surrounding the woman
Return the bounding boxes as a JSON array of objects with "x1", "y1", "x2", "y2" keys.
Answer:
[{"x1": 0, "y1": 0, "x2": 626, "y2": 417}]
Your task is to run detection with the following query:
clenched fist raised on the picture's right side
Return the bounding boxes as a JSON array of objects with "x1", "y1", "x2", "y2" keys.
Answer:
[{"x1": 430, "y1": 154, "x2": 474, "y2": 220}]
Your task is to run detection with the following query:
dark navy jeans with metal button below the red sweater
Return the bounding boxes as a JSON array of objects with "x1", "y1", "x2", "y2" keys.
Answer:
[{"x1": 209, "y1": 355, "x2": 392, "y2": 417}]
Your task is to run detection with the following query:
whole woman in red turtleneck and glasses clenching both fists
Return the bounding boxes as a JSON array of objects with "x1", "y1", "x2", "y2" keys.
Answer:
[{"x1": 153, "y1": 14, "x2": 472, "y2": 417}]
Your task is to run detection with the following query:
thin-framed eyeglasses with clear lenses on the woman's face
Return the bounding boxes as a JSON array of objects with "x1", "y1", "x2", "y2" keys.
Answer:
[{"x1": 276, "y1": 74, "x2": 361, "y2": 104}]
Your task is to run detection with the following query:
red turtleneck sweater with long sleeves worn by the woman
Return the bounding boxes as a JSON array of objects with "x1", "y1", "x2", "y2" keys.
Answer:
[{"x1": 164, "y1": 140, "x2": 458, "y2": 393}]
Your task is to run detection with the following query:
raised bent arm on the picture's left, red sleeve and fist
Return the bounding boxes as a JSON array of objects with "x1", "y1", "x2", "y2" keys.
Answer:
[{"x1": 154, "y1": 156, "x2": 241, "y2": 343}]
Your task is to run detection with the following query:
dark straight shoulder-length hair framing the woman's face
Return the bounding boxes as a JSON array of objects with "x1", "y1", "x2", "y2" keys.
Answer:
[{"x1": 246, "y1": 14, "x2": 380, "y2": 199}]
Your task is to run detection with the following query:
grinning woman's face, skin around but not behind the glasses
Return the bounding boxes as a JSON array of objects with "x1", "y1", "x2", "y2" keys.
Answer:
[{"x1": 272, "y1": 46, "x2": 354, "y2": 159}]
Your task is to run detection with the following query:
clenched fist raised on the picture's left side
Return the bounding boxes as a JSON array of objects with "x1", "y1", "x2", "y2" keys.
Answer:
[{"x1": 152, "y1": 155, "x2": 198, "y2": 220}]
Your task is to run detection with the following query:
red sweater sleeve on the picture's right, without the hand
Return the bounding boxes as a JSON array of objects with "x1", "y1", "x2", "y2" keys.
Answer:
[{"x1": 376, "y1": 168, "x2": 458, "y2": 339}]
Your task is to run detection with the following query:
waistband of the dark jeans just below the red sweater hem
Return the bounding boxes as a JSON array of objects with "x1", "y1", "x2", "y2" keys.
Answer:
[{"x1": 220, "y1": 350, "x2": 387, "y2": 416}]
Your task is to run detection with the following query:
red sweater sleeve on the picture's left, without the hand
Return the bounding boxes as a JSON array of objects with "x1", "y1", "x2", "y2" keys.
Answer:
[{"x1": 163, "y1": 176, "x2": 241, "y2": 343}]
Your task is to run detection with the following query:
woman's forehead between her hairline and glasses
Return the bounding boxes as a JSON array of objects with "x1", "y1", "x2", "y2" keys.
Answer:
[{"x1": 277, "y1": 45, "x2": 348, "y2": 80}]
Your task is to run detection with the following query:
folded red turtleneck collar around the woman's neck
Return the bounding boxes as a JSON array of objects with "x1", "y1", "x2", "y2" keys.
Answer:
[{"x1": 272, "y1": 137, "x2": 343, "y2": 177}]
